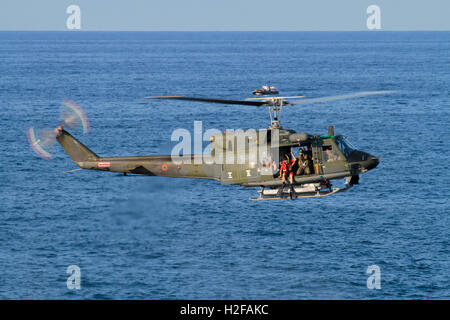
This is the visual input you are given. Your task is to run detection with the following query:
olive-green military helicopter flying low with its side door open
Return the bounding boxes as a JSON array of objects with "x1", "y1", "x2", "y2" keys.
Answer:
[{"x1": 28, "y1": 91, "x2": 394, "y2": 200}]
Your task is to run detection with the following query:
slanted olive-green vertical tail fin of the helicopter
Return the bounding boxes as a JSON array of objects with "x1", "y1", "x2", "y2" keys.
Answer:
[{"x1": 55, "y1": 126, "x2": 99, "y2": 167}]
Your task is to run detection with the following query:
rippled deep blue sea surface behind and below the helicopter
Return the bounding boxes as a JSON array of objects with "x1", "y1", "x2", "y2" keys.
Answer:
[{"x1": 0, "y1": 32, "x2": 450, "y2": 299}]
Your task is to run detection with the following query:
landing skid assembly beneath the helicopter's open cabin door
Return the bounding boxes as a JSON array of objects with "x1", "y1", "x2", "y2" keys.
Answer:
[{"x1": 250, "y1": 184, "x2": 353, "y2": 201}]
